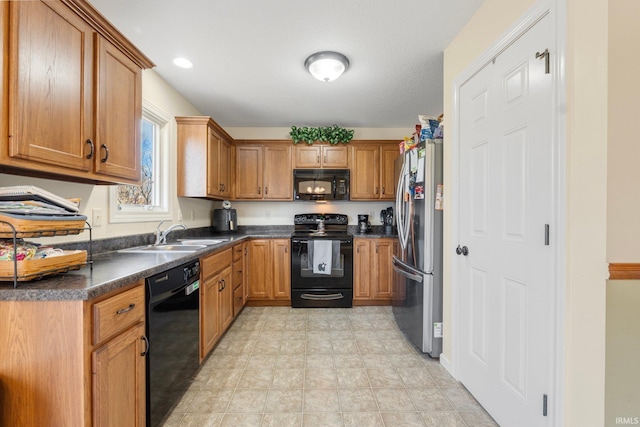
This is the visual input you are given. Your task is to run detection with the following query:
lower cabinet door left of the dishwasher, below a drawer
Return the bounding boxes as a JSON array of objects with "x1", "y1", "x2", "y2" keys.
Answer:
[{"x1": 92, "y1": 322, "x2": 146, "y2": 427}]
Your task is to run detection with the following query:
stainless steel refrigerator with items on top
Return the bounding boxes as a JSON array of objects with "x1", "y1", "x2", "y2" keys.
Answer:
[{"x1": 393, "y1": 139, "x2": 443, "y2": 357}]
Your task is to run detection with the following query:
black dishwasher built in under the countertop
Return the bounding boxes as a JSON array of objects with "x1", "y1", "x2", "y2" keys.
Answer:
[{"x1": 146, "y1": 261, "x2": 200, "y2": 427}]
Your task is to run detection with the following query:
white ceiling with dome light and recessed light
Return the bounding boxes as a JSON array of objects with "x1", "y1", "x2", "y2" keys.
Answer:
[{"x1": 89, "y1": 0, "x2": 482, "y2": 128}]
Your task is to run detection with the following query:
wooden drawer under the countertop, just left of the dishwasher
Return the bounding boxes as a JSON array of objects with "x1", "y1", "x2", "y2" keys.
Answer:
[{"x1": 93, "y1": 286, "x2": 144, "y2": 345}]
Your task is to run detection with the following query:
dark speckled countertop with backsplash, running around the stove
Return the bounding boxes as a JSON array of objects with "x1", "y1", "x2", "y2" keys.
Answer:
[{"x1": 0, "y1": 226, "x2": 397, "y2": 301}]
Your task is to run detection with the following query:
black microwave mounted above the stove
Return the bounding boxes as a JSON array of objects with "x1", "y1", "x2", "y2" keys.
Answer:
[{"x1": 293, "y1": 169, "x2": 349, "y2": 200}]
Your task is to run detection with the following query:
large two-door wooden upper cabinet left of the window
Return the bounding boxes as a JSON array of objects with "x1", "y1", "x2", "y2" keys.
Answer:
[{"x1": 0, "y1": 0, "x2": 153, "y2": 183}]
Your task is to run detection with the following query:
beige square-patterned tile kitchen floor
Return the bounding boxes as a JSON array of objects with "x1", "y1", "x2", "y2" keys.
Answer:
[{"x1": 159, "y1": 307, "x2": 497, "y2": 427}]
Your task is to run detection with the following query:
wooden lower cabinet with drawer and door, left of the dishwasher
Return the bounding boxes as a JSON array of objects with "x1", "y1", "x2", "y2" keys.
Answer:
[{"x1": 0, "y1": 281, "x2": 146, "y2": 426}]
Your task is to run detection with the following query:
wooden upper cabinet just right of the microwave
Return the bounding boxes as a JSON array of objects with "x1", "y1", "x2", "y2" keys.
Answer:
[{"x1": 351, "y1": 141, "x2": 400, "y2": 200}]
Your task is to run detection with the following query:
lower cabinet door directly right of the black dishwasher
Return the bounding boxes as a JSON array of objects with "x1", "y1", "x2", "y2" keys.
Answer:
[{"x1": 200, "y1": 274, "x2": 222, "y2": 360}]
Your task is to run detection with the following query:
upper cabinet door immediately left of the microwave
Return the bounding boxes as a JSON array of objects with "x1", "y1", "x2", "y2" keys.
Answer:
[{"x1": 264, "y1": 146, "x2": 293, "y2": 200}]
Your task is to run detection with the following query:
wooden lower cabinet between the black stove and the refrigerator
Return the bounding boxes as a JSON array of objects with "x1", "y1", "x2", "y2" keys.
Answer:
[{"x1": 353, "y1": 238, "x2": 398, "y2": 305}]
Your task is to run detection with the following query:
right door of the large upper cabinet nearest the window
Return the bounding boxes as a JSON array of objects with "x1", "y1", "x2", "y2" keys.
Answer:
[{"x1": 94, "y1": 35, "x2": 142, "y2": 183}]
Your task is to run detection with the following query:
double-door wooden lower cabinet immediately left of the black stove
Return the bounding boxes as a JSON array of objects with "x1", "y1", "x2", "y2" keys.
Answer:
[{"x1": 247, "y1": 239, "x2": 291, "y2": 305}]
